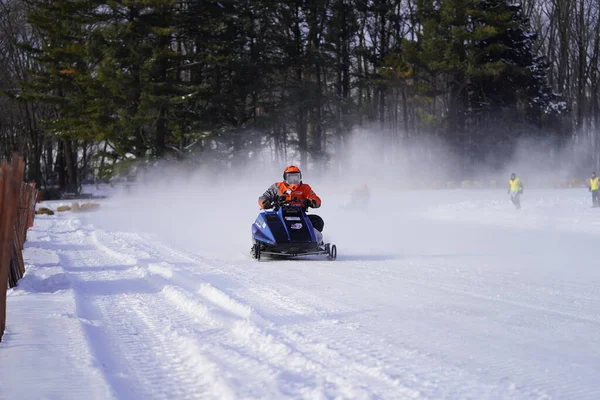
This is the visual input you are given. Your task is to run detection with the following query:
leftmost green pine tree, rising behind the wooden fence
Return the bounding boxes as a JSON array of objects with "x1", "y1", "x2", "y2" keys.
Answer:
[{"x1": 23, "y1": 0, "x2": 100, "y2": 192}]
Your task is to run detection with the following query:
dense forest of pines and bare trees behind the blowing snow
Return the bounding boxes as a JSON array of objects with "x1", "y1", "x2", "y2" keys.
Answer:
[{"x1": 0, "y1": 0, "x2": 600, "y2": 193}]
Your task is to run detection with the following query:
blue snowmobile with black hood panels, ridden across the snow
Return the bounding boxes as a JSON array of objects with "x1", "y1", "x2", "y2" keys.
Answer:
[{"x1": 252, "y1": 197, "x2": 337, "y2": 260}]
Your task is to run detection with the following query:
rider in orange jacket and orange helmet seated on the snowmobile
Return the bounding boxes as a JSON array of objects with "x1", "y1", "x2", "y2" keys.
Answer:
[{"x1": 258, "y1": 165, "x2": 325, "y2": 232}]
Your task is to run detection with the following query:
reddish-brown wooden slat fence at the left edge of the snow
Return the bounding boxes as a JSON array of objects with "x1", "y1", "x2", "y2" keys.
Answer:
[{"x1": 0, "y1": 157, "x2": 38, "y2": 341}]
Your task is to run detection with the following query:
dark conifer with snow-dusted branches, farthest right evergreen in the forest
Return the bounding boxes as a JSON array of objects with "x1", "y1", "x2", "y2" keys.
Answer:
[{"x1": 471, "y1": 0, "x2": 564, "y2": 124}]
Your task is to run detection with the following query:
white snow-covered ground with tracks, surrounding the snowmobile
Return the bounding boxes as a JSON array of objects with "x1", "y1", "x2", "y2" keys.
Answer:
[{"x1": 0, "y1": 189, "x2": 600, "y2": 400}]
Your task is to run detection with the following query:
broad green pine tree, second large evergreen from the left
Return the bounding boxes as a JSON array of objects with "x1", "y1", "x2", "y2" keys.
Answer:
[{"x1": 90, "y1": 0, "x2": 182, "y2": 158}]
